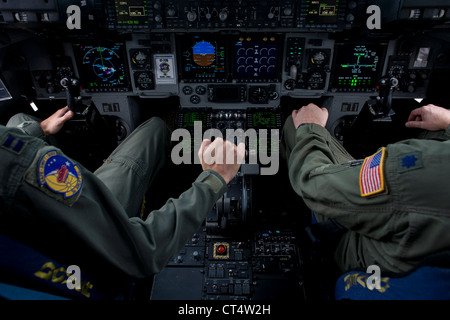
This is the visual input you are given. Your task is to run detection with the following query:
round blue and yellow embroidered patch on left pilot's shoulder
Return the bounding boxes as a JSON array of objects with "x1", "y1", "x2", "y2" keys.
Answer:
[{"x1": 37, "y1": 150, "x2": 83, "y2": 199}]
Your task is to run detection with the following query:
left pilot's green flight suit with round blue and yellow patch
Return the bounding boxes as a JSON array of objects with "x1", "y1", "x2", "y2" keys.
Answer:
[{"x1": 0, "y1": 118, "x2": 227, "y2": 278}]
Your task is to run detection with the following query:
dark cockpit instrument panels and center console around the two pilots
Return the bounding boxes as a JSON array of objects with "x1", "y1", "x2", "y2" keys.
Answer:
[{"x1": 0, "y1": 0, "x2": 450, "y2": 302}]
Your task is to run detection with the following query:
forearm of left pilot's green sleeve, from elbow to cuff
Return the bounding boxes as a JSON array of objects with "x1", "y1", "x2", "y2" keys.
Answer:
[{"x1": 129, "y1": 170, "x2": 227, "y2": 274}]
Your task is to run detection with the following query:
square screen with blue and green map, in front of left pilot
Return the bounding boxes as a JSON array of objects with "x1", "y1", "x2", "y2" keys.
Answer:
[{"x1": 74, "y1": 43, "x2": 129, "y2": 92}]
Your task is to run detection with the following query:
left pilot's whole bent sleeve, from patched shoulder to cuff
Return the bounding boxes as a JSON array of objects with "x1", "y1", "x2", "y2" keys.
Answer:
[{"x1": 9, "y1": 139, "x2": 227, "y2": 278}]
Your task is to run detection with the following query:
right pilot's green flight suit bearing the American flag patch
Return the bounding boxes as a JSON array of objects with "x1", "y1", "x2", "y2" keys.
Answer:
[{"x1": 283, "y1": 117, "x2": 450, "y2": 273}]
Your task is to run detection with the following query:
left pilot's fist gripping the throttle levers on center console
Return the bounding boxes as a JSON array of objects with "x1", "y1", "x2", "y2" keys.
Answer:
[{"x1": 198, "y1": 138, "x2": 245, "y2": 184}]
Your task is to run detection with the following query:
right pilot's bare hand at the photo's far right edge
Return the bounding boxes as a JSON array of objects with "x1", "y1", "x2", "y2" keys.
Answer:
[{"x1": 405, "y1": 104, "x2": 450, "y2": 131}]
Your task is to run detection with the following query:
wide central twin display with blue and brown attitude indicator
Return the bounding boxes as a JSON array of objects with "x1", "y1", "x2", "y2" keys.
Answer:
[{"x1": 177, "y1": 33, "x2": 283, "y2": 83}]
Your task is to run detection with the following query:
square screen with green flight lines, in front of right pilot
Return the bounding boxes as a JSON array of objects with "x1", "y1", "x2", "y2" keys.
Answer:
[{"x1": 332, "y1": 44, "x2": 386, "y2": 91}]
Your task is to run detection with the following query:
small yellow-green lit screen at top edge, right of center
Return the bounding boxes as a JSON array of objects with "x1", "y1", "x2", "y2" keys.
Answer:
[{"x1": 306, "y1": 0, "x2": 342, "y2": 24}]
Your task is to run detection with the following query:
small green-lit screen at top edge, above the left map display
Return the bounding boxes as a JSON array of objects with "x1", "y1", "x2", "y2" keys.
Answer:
[{"x1": 114, "y1": 0, "x2": 149, "y2": 26}]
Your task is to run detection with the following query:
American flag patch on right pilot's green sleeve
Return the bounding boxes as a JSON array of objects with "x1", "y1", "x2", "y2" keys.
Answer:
[{"x1": 359, "y1": 147, "x2": 386, "y2": 197}]
